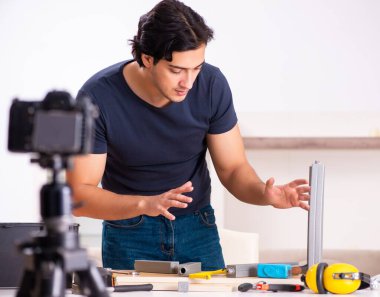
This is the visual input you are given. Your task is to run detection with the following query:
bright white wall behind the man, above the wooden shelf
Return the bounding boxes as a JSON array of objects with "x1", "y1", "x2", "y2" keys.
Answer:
[{"x1": 0, "y1": 0, "x2": 380, "y2": 229}]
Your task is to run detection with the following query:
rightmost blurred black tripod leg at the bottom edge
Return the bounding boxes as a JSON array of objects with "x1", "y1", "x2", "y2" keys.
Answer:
[{"x1": 76, "y1": 265, "x2": 109, "y2": 297}]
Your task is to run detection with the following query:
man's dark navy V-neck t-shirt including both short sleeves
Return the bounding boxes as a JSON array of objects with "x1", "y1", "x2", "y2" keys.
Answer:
[{"x1": 78, "y1": 61, "x2": 237, "y2": 215}]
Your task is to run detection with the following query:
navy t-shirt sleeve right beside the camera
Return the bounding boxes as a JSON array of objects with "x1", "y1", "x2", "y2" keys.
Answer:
[{"x1": 77, "y1": 89, "x2": 107, "y2": 154}]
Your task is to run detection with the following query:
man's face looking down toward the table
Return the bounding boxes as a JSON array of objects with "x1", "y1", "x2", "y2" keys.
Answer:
[{"x1": 151, "y1": 44, "x2": 206, "y2": 102}]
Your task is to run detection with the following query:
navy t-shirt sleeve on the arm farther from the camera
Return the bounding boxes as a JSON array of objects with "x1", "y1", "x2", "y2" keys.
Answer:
[{"x1": 208, "y1": 71, "x2": 237, "y2": 134}]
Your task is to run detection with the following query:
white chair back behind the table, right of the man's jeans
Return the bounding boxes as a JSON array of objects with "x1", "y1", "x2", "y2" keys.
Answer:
[{"x1": 218, "y1": 228, "x2": 259, "y2": 265}]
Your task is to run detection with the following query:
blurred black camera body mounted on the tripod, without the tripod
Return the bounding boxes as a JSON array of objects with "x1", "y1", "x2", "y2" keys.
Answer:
[{"x1": 8, "y1": 91, "x2": 97, "y2": 155}]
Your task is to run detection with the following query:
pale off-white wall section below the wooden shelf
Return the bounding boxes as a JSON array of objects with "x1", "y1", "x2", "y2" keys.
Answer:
[{"x1": 223, "y1": 150, "x2": 380, "y2": 250}]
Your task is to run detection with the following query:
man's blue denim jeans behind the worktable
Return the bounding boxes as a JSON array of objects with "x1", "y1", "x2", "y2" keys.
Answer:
[{"x1": 102, "y1": 205, "x2": 225, "y2": 270}]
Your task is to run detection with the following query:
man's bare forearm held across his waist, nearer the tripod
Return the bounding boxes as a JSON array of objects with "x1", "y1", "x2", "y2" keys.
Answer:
[{"x1": 73, "y1": 185, "x2": 145, "y2": 220}]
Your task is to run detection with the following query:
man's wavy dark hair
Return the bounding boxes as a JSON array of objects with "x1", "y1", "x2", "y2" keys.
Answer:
[{"x1": 130, "y1": 0, "x2": 214, "y2": 66}]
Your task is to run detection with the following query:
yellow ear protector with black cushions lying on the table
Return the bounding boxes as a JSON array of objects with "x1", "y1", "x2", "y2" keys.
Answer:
[{"x1": 301, "y1": 263, "x2": 371, "y2": 294}]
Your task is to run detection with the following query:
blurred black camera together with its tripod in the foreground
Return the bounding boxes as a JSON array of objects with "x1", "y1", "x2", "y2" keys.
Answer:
[{"x1": 8, "y1": 91, "x2": 109, "y2": 297}]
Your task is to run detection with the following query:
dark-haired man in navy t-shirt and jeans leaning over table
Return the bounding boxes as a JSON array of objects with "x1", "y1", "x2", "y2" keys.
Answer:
[{"x1": 68, "y1": 0, "x2": 310, "y2": 270}]
